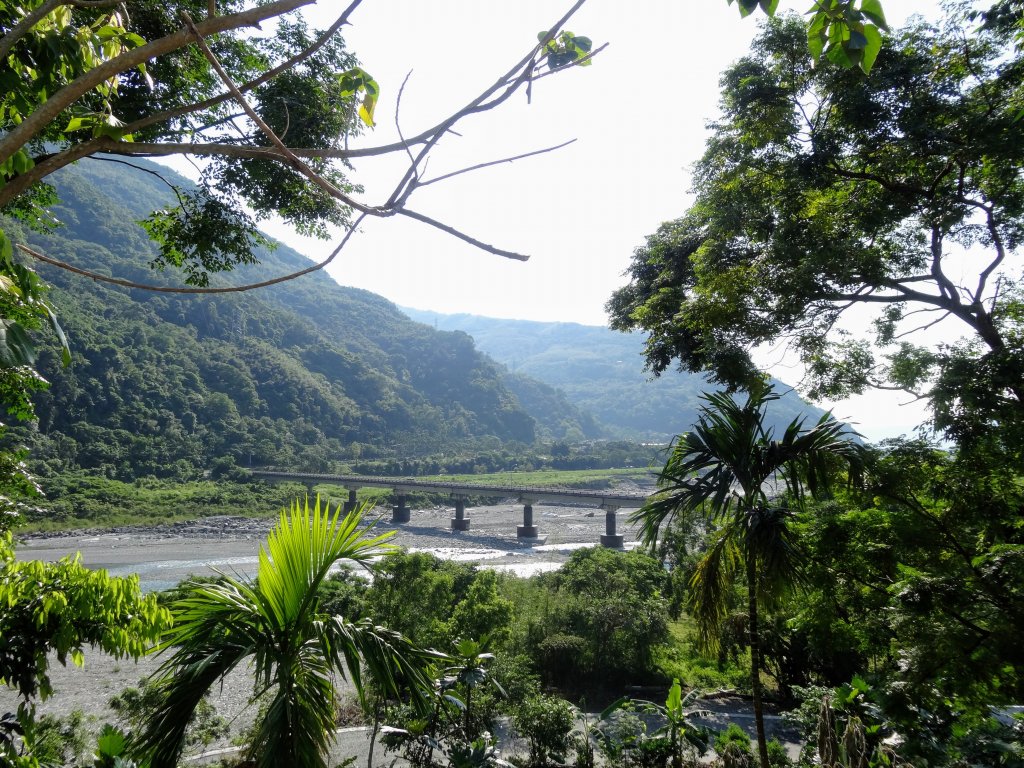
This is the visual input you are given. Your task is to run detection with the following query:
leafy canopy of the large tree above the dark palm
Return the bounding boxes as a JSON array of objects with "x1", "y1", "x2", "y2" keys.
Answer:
[{"x1": 608, "y1": 6, "x2": 1024, "y2": 444}]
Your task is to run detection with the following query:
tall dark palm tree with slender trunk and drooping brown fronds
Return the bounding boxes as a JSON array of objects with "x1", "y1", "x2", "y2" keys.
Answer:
[{"x1": 630, "y1": 380, "x2": 863, "y2": 766}]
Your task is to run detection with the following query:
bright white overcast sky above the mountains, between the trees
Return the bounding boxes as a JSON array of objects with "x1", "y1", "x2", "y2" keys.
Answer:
[{"x1": 251, "y1": 0, "x2": 954, "y2": 439}]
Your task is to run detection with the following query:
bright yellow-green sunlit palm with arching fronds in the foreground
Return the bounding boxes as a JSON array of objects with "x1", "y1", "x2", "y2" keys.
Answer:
[{"x1": 133, "y1": 498, "x2": 431, "y2": 768}]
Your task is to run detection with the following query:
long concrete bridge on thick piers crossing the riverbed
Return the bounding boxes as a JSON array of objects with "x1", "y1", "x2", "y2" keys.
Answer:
[{"x1": 252, "y1": 470, "x2": 647, "y2": 548}]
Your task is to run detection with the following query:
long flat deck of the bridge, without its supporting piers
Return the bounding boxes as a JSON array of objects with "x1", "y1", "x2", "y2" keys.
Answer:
[{"x1": 252, "y1": 470, "x2": 647, "y2": 509}]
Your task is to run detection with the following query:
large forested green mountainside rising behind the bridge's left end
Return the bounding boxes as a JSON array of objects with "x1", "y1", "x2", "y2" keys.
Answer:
[{"x1": 3, "y1": 160, "x2": 601, "y2": 479}]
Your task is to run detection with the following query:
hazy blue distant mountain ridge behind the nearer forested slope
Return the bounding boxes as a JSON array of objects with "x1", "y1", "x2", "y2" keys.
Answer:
[{"x1": 403, "y1": 309, "x2": 823, "y2": 440}]
